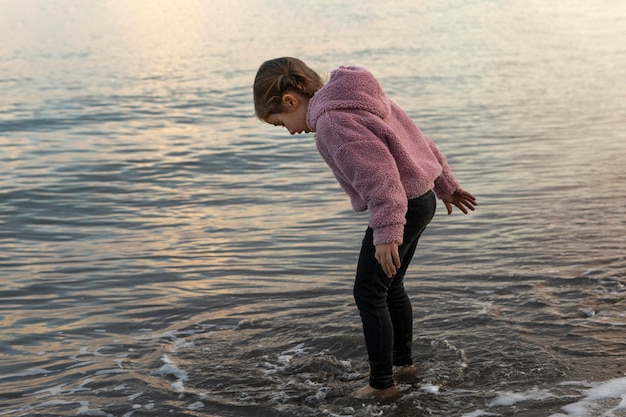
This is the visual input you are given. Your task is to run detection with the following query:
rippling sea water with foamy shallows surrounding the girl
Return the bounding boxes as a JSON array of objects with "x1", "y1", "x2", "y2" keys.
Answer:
[{"x1": 0, "y1": 0, "x2": 626, "y2": 417}]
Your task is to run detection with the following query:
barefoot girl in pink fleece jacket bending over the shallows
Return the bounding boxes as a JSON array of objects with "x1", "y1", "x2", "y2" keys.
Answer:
[{"x1": 254, "y1": 57, "x2": 477, "y2": 399}]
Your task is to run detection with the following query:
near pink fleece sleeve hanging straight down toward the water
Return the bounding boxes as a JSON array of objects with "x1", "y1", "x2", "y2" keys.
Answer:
[{"x1": 318, "y1": 114, "x2": 407, "y2": 245}]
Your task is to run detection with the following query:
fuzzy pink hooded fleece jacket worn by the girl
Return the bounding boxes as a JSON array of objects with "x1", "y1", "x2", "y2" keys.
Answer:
[{"x1": 306, "y1": 67, "x2": 459, "y2": 245}]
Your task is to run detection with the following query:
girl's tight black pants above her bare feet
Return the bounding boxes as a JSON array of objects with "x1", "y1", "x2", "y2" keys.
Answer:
[{"x1": 354, "y1": 191, "x2": 437, "y2": 389}]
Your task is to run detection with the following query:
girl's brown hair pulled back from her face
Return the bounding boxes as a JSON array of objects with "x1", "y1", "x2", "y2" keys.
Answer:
[{"x1": 253, "y1": 57, "x2": 324, "y2": 121}]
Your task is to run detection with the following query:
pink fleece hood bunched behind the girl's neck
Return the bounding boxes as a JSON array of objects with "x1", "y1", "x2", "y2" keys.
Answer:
[{"x1": 307, "y1": 66, "x2": 391, "y2": 131}]
